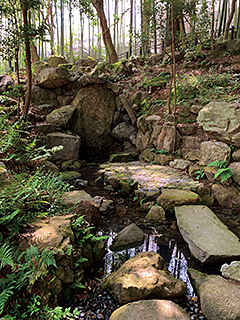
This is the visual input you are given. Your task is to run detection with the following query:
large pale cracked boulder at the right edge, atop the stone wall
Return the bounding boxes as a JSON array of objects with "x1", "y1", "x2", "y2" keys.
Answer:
[{"x1": 197, "y1": 102, "x2": 240, "y2": 148}]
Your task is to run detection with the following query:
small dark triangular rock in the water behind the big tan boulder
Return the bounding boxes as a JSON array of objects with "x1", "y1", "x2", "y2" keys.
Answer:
[{"x1": 111, "y1": 223, "x2": 144, "y2": 251}]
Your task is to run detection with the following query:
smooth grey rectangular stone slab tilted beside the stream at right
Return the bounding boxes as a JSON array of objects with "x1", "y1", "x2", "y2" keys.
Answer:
[{"x1": 174, "y1": 205, "x2": 240, "y2": 263}]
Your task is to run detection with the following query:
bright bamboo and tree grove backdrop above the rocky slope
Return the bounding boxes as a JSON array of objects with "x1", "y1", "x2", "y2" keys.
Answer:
[{"x1": 0, "y1": 0, "x2": 240, "y2": 73}]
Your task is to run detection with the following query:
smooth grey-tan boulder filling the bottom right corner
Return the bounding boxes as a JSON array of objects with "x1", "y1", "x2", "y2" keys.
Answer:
[{"x1": 188, "y1": 269, "x2": 240, "y2": 320}]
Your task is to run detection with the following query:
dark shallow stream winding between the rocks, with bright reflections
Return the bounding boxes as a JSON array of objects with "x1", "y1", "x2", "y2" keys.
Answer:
[{"x1": 69, "y1": 165, "x2": 231, "y2": 320}]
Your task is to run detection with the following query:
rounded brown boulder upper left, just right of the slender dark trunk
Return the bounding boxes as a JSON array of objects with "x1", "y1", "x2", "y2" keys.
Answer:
[{"x1": 35, "y1": 67, "x2": 70, "y2": 89}]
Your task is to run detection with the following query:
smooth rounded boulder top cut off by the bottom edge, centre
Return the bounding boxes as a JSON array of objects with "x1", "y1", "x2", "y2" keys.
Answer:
[{"x1": 110, "y1": 300, "x2": 191, "y2": 320}]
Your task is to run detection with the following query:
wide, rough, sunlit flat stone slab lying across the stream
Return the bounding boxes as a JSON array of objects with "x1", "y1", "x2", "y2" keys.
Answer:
[{"x1": 99, "y1": 161, "x2": 200, "y2": 191}]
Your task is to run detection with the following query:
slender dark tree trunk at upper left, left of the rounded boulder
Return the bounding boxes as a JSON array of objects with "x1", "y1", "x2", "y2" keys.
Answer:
[{"x1": 22, "y1": 6, "x2": 32, "y2": 116}]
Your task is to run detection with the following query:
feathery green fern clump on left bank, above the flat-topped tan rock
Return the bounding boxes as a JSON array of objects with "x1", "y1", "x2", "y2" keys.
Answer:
[{"x1": 0, "y1": 171, "x2": 69, "y2": 235}]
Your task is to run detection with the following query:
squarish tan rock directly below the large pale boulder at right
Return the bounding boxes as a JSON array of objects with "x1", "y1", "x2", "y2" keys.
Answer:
[{"x1": 199, "y1": 141, "x2": 231, "y2": 166}]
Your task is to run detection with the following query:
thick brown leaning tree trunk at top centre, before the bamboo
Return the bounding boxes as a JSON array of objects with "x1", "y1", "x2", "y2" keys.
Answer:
[{"x1": 91, "y1": 0, "x2": 118, "y2": 63}]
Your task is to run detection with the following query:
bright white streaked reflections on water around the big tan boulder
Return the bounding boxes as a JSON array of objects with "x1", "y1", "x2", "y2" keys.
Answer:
[{"x1": 104, "y1": 231, "x2": 195, "y2": 297}]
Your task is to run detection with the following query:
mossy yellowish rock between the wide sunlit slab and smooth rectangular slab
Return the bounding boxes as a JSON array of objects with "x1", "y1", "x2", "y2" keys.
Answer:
[{"x1": 157, "y1": 189, "x2": 198, "y2": 211}]
